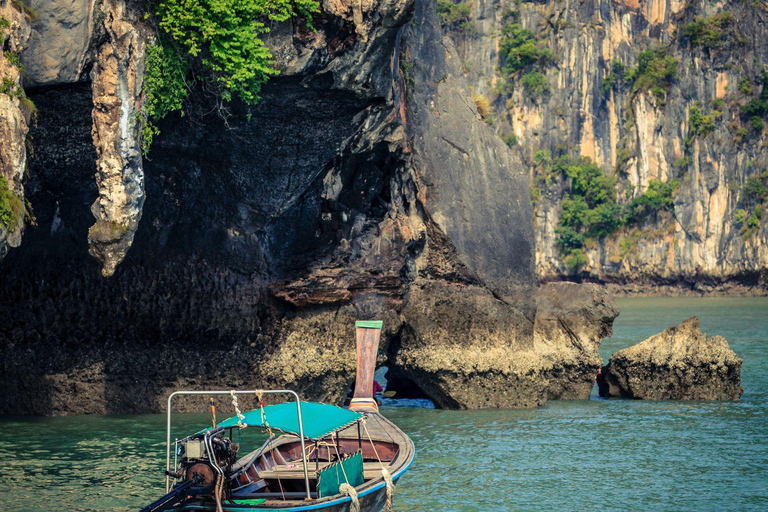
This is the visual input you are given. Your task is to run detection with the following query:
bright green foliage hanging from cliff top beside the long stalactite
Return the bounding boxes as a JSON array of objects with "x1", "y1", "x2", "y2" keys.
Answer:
[{"x1": 143, "y1": 0, "x2": 320, "y2": 151}]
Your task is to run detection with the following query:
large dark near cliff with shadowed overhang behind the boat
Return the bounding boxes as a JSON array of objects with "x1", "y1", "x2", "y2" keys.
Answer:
[{"x1": 0, "y1": 0, "x2": 617, "y2": 414}]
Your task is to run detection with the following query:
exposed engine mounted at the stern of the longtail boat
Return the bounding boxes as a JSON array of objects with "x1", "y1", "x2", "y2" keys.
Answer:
[{"x1": 174, "y1": 430, "x2": 239, "y2": 494}]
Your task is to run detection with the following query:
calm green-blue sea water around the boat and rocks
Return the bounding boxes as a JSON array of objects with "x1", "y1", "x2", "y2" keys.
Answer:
[{"x1": 0, "y1": 298, "x2": 768, "y2": 512}]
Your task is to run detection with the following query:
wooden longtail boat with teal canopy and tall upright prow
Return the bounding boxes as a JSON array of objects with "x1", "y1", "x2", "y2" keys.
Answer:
[{"x1": 140, "y1": 321, "x2": 414, "y2": 512}]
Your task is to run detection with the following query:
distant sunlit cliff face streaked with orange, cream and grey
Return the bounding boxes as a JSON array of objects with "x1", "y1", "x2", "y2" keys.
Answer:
[{"x1": 444, "y1": 0, "x2": 768, "y2": 294}]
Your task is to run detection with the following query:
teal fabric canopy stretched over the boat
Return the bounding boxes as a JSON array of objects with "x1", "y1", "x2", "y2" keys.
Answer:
[{"x1": 218, "y1": 402, "x2": 363, "y2": 440}]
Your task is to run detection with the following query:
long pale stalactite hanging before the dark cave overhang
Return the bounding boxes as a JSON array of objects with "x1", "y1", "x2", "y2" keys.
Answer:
[{"x1": 88, "y1": 0, "x2": 147, "y2": 277}]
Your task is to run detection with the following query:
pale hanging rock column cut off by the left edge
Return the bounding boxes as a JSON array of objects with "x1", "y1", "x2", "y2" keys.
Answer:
[{"x1": 0, "y1": 0, "x2": 34, "y2": 259}]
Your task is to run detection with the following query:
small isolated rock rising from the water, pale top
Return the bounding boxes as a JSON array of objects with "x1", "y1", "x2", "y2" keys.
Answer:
[{"x1": 597, "y1": 316, "x2": 744, "y2": 400}]
